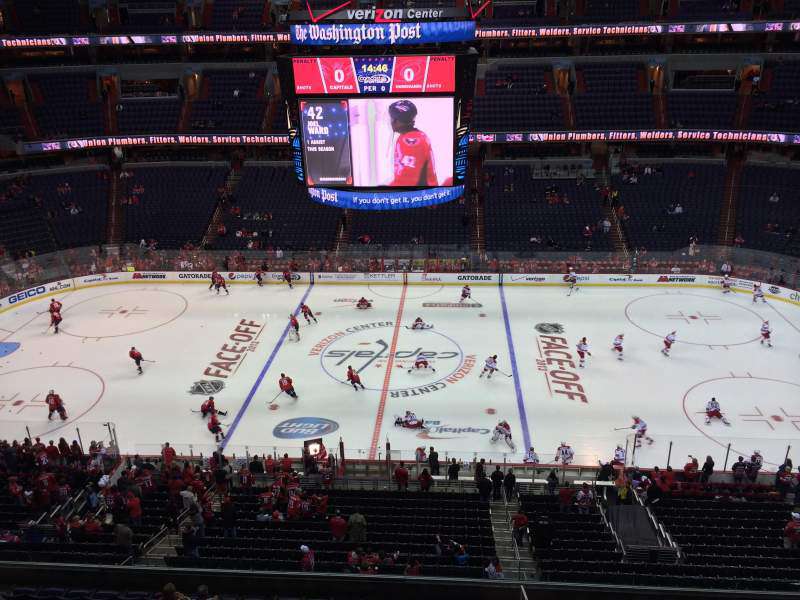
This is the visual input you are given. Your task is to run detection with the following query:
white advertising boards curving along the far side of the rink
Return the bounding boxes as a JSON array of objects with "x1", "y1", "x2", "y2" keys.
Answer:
[{"x1": 0, "y1": 271, "x2": 800, "y2": 313}]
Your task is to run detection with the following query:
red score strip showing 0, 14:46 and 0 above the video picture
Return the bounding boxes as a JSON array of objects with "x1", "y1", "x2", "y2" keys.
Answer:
[{"x1": 292, "y1": 55, "x2": 456, "y2": 95}]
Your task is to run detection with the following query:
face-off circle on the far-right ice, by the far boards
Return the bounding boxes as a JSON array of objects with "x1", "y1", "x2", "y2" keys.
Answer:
[{"x1": 625, "y1": 293, "x2": 763, "y2": 347}]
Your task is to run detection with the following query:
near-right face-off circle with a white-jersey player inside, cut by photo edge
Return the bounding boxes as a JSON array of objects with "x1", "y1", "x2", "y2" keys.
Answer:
[{"x1": 683, "y1": 376, "x2": 800, "y2": 465}]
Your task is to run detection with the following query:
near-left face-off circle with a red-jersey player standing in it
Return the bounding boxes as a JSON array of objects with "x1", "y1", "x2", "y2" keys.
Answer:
[{"x1": 0, "y1": 365, "x2": 106, "y2": 441}]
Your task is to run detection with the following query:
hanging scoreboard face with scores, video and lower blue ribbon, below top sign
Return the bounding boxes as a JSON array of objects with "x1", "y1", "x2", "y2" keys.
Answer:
[{"x1": 278, "y1": 51, "x2": 478, "y2": 210}]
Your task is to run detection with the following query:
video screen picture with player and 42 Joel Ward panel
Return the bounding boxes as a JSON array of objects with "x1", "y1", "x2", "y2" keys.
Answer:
[{"x1": 299, "y1": 96, "x2": 454, "y2": 187}]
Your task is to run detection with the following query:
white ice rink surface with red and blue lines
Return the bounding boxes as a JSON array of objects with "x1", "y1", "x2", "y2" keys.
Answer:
[{"x1": 0, "y1": 283, "x2": 800, "y2": 468}]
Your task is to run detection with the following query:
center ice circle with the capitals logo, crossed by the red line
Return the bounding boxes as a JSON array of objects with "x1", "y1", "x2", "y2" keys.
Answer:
[{"x1": 309, "y1": 321, "x2": 476, "y2": 398}]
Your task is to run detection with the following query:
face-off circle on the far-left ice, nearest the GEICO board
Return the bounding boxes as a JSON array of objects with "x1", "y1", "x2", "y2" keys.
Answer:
[{"x1": 60, "y1": 289, "x2": 189, "y2": 340}]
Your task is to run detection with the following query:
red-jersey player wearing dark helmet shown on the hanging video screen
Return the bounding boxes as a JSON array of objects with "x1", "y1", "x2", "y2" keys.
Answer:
[{"x1": 389, "y1": 100, "x2": 439, "y2": 187}]
